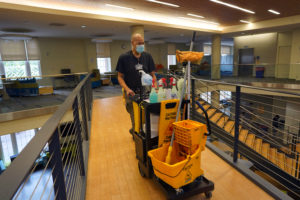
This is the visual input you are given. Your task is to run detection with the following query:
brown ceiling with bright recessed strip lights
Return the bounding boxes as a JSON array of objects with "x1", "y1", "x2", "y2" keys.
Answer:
[{"x1": 0, "y1": 0, "x2": 300, "y2": 42}]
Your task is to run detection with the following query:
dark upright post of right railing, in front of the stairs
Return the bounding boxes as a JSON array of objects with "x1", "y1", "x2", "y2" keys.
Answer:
[{"x1": 233, "y1": 86, "x2": 241, "y2": 162}]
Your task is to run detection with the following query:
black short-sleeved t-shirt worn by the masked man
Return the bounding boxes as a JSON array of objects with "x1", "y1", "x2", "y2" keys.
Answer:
[{"x1": 116, "y1": 51, "x2": 155, "y2": 91}]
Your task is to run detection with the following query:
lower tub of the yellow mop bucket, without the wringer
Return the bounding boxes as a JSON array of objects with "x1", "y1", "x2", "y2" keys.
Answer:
[{"x1": 148, "y1": 142, "x2": 203, "y2": 189}]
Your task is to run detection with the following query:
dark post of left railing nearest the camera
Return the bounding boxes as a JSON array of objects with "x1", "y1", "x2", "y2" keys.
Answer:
[{"x1": 49, "y1": 129, "x2": 67, "y2": 200}]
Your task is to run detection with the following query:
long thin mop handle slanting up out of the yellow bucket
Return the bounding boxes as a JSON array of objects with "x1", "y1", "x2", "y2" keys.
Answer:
[{"x1": 166, "y1": 31, "x2": 196, "y2": 164}]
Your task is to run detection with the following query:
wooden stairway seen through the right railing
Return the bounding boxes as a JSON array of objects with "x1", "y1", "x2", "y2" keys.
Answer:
[{"x1": 197, "y1": 100, "x2": 300, "y2": 180}]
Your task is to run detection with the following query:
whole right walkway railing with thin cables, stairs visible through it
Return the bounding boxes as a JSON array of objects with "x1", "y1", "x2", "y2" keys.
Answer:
[{"x1": 192, "y1": 78, "x2": 300, "y2": 198}]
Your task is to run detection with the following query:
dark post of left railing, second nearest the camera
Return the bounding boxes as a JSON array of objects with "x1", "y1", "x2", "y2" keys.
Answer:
[{"x1": 73, "y1": 97, "x2": 85, "y2": 176}]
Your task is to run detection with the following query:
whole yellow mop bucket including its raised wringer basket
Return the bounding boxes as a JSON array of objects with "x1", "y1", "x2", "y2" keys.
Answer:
[{"x1": 148, "y1": 120, "x2": 207, "y2": 189}]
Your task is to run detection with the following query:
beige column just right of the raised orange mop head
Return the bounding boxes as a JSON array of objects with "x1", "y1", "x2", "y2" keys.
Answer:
[{"x1": 211, "y1": 35, "x2": 221, "y2": 80}]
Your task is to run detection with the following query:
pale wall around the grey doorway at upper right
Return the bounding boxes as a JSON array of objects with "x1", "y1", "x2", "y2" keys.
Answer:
[{"x1": 234, "y1": 33, "x2": 277, "y2": 77}]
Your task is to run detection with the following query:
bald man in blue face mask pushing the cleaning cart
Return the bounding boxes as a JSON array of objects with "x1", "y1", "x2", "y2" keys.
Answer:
[{"x1": 116, "y1": 34, "x2": 156, "y2": 134}]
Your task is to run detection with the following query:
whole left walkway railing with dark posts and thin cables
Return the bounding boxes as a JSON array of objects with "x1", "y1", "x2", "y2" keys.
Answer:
[{"x1": 0, "y1": 74, "x2": 92, "y2": 200}]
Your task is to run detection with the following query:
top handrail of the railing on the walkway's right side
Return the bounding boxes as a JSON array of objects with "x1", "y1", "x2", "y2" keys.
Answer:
[{"x1": 192, "y1": 76, "x2": 300, "y2": 97}]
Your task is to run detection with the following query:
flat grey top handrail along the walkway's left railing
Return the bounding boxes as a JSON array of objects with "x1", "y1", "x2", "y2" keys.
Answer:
[{"x1": 0, "y1": 74, "x2": 91, "y2": 199}]
